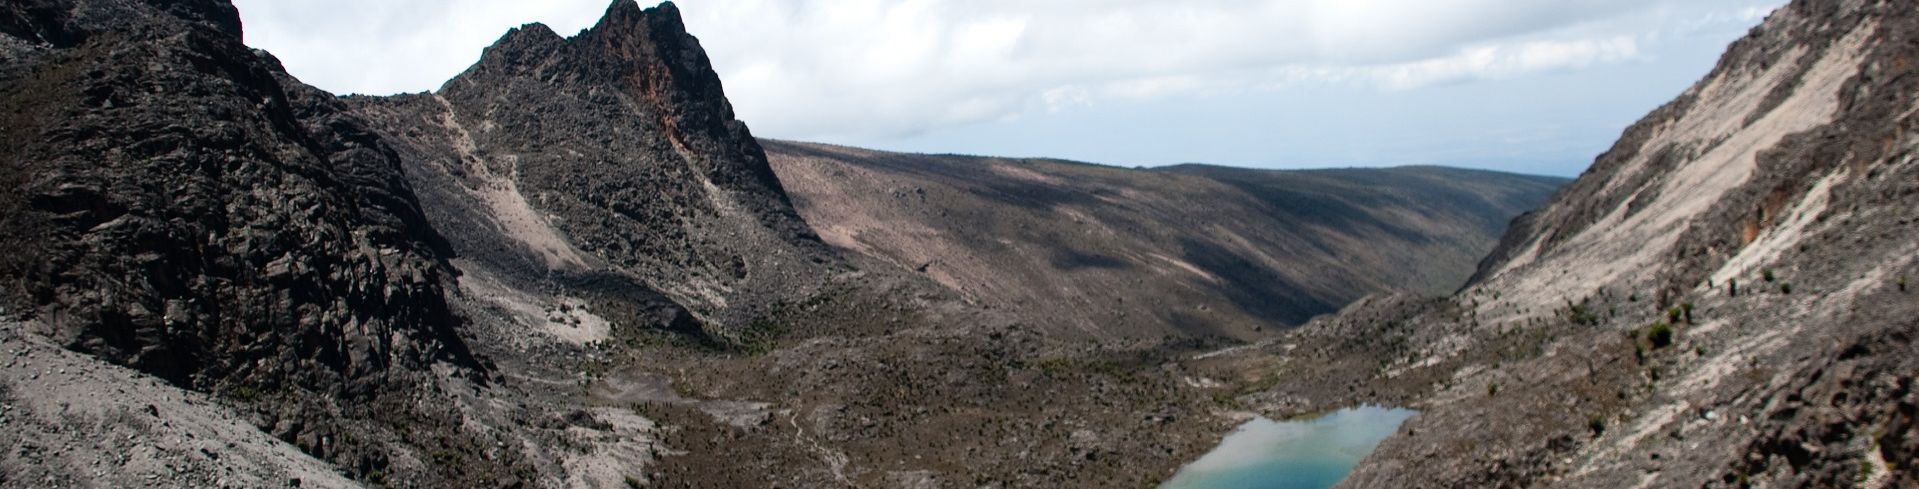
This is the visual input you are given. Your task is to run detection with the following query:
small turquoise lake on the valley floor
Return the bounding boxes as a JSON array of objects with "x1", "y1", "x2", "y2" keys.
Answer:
[{"x1": 1161, "y1": 407, "x2": 1414, "y2": 489}]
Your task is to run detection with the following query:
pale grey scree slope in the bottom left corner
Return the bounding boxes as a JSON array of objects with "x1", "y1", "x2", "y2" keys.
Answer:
[{"x1": 0, "y1": 322, "x2": 359, "y2": 487}]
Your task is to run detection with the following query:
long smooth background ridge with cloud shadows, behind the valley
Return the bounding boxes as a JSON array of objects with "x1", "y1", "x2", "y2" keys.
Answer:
[{"x1": 766, "y1": 142, "x2": 1564, "y2": 339}]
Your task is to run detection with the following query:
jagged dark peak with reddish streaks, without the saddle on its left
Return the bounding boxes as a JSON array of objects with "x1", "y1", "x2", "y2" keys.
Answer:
[{"x1": 424, "y1": 0, "x2": 825, "y2": 331}]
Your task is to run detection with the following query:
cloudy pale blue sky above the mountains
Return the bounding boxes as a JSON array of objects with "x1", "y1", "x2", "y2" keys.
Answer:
[{"x1": 234, "y1": 0, "x2": 1785, "y2": 176}]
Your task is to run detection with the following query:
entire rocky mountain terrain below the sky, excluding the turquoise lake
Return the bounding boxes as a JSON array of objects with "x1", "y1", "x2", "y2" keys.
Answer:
[{"x1": 22, "y1": 0, "x2": 1895, "y2": 487}]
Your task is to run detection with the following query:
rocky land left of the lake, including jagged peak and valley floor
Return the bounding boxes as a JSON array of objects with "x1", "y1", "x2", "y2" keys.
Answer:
[{"x1": 0, "y1": 0, "x2": 1228, "y2": 487}]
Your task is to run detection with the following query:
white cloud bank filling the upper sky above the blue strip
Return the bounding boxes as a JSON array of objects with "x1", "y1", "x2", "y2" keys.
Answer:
[{"x1": 238, "y1": 0, "x2": 1779, "y2": 138}]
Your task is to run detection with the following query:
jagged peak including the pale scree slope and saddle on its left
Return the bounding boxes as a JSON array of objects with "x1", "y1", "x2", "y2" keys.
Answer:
[{"x1": 353, "y1": 2, "x2": 837, "y2": 336}]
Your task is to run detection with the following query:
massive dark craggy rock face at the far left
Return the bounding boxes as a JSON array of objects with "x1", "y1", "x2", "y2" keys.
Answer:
[{"x1": 0, "y1": 2, "x2": 462, "y2": 391}]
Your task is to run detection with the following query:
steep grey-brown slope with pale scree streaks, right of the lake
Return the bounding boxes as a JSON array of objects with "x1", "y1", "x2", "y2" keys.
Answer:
[{"x1": 1220, "y1": 0, "x2": 1919, "y2": 487}]
